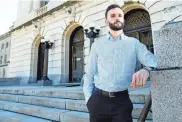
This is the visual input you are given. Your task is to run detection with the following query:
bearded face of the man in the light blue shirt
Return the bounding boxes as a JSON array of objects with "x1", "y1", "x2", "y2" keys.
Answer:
[{"x1": 106, "y1": 8, "x2": 124, "y2": 31}]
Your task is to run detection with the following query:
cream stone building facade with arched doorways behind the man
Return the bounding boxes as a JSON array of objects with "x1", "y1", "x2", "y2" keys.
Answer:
[{"x1": 0, "y1": 0, "x2": 182, "y2": 85}]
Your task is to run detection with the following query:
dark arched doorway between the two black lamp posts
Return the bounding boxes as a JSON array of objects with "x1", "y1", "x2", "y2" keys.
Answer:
[{"x1": 69, "y1": 26, "x2": 84, "y2": 82}]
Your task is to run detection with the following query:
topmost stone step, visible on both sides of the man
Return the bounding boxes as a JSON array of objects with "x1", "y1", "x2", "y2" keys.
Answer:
[{"x1": 0, "y1": 87, "x2": 150, "y2": 103}]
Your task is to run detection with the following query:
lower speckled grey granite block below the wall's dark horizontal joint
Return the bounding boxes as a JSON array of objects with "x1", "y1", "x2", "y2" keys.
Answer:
[{"x1": 151, "y1": 70, "x2": 182, "y2": 122}]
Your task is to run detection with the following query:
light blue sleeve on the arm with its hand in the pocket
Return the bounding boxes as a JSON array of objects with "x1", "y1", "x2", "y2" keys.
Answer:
[{"x1": 83, "y1": 43, "x2": 98, "y2": 103}]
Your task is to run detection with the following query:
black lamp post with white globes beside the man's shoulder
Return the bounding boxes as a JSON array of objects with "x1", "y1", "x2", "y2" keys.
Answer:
[{"x1": 85, "y1": 23, "x2": 100, "y2": 47}]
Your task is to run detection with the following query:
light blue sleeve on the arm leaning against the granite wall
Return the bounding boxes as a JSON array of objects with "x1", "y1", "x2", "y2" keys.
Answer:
[{"x1": 136, "y1": 40, "x2": 157, "y2": 68}]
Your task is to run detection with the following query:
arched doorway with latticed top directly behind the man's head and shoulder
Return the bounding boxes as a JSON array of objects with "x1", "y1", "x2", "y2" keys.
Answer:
[{"x1": 124, "y1": 9, "x2": 154, "y2": 70}]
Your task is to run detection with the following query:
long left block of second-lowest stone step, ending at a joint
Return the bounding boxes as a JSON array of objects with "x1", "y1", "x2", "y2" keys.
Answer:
[{"x1": 0, "y1": 101, "x2": 69, "y2": 121}]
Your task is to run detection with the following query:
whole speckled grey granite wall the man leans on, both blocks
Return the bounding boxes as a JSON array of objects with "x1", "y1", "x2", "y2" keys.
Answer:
[{"x1": 150, "y1": 22, "x2": 182, "y2": 122}]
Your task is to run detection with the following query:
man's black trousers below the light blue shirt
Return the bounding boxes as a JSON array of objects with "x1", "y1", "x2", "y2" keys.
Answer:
[{"x1": 86, "y1": 89, "x2": 133, "y2": 122}]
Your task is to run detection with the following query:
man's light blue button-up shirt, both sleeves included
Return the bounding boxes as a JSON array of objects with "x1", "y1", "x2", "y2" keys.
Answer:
[{"x1": 83, "y1": 33, "x2": 157, "y2": 103}]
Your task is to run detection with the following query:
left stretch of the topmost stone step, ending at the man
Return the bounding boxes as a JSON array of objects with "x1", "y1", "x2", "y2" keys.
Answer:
[{"x1": 0, "y1": 86, "x2": 84, "y2": 99}]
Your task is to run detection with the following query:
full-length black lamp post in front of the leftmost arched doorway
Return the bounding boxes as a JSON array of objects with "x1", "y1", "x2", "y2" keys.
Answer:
[{"x1": 41, "y1": 39, "x2": 54, "y2": 86}]
